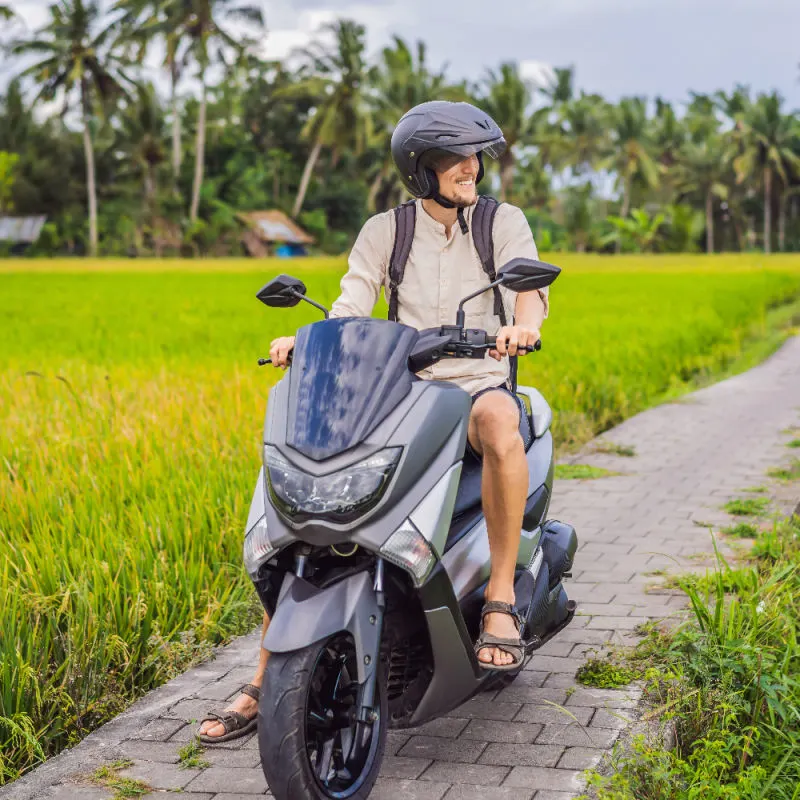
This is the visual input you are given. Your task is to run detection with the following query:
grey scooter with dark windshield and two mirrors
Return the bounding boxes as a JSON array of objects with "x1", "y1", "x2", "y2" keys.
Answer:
[{"x1": 244, "y1": 259, "x2": 577, "y2": 800}]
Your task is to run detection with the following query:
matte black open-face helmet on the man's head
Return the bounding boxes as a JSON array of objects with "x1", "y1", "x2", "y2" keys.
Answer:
[{"x1": 392, "y1": 100, "x2": 506, "y2": 206}]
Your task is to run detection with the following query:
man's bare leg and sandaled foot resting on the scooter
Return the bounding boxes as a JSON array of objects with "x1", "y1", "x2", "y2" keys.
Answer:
[{"x1": 469, "y1": 391, "x2": 528, "y2": 666}]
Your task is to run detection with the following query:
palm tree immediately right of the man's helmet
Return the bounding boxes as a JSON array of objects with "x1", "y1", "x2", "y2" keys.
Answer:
[{"x1": 479, "y1": 62, "x2": 533, "y2": 201}]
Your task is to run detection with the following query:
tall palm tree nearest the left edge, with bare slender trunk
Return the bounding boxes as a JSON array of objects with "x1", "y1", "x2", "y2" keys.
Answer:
[{"x1": 11, "y1": 0, "x2": 133, "y2": 256}]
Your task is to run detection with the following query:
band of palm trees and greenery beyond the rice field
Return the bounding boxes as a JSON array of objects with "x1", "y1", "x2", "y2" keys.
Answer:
[{"x1": 0, "y1": 14, "x2": 800, "y2": 257}]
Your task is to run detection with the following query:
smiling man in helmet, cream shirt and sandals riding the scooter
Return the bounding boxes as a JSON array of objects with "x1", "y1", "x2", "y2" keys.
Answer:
[{"x1": 201, "y1": 101, "x2": 548, "y2": 741}]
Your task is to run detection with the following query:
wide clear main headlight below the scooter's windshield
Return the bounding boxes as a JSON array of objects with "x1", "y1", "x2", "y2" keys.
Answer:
[{"x1": 264, "y1": 445, "x2": 402, "y2": 522}]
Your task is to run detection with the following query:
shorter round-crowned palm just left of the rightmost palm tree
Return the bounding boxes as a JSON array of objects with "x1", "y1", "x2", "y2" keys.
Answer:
[{"x1": 676, "y1": 134, "x2": 729, "y2": 253}]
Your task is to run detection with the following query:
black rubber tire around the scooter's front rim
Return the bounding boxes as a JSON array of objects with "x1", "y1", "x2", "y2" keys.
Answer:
[{"x1": 258, "y1": 637, "x2": 389, "y2": 800}]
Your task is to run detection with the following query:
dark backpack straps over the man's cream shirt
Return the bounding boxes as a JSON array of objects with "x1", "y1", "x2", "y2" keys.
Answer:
[{"x1": 388, "y1": 195, "x2": 517, "y2": 392}]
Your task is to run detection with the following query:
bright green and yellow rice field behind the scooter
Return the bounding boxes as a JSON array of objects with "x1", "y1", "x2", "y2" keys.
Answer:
[{"x1": 0, "y1": 255, "x2": 800, "y2": 784}]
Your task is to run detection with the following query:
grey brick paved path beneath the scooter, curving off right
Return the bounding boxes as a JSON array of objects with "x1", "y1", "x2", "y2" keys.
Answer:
[{"x1": 6, "y1": 337, "x2": 800, "y2": 800}]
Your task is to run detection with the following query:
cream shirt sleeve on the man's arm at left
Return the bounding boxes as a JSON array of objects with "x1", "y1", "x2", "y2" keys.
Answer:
[{"x1": 331, "y1": 214, "x2": 393, "y2": 317}]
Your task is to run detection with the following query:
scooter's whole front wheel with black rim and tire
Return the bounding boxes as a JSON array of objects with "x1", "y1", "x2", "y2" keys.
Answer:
[{"x1": 258, "y1": 634, "x2": 388, "y2": 800}]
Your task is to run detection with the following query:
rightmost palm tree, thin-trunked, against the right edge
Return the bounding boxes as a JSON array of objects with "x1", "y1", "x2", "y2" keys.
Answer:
[{"x1": 733, "y1": 92, "x2": 800, "y2": 253}]
